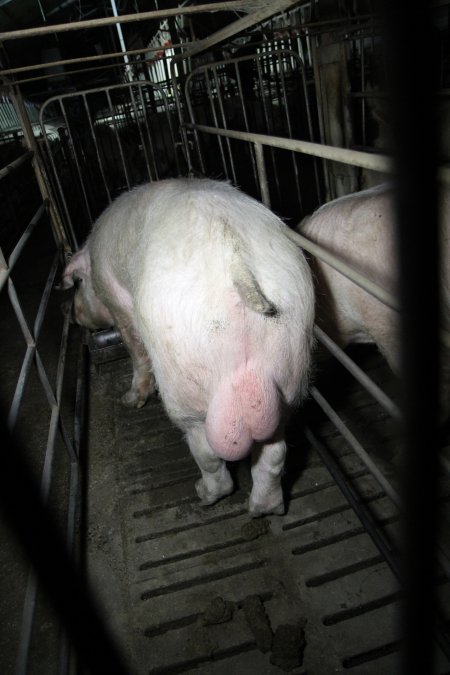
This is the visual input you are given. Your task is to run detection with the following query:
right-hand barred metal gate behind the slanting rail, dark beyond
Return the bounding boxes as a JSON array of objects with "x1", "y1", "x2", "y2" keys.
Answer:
[{"x1": 184, "y1": 43, "x2": 323, "y2": 219}]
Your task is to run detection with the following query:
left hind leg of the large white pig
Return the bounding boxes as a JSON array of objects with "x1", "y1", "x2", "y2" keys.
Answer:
[{"x1": 186, "y1": 424, "x2": 233, "y2": 506}]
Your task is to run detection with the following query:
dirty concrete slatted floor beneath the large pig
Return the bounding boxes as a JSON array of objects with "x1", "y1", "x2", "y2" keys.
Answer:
[{"x1": 89, "y1": 355, "x2": 449, "y2": 675}]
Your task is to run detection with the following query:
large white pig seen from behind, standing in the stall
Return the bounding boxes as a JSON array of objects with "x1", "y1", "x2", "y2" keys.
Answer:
[{"x1": 64, "y1": 179, "x2": 314, "y2": 515}]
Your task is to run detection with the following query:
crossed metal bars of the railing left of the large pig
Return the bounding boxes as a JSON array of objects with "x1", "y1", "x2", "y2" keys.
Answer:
[{"x1": 0, "y1": 153, "x2": 84, "y2": 674}]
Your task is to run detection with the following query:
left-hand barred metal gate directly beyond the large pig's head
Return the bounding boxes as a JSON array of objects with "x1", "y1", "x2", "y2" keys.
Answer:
[{"x1": 40, "y1": 82, "x2": 184, "y2": 245}]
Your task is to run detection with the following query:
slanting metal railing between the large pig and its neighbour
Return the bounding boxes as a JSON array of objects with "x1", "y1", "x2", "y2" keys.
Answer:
[{"x1": 179, "y1": 113, "x2": 450, "y2": 658}]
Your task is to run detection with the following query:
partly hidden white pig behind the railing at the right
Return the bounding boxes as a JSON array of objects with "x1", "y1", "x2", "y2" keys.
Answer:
[{"x1": 297, "y1": 183, "x2": 450, "y2": 372}]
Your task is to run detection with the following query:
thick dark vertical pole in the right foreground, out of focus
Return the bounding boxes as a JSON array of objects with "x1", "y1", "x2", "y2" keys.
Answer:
[{"x1": 384, "y1": 1, "x2": 439, "y2": 675}]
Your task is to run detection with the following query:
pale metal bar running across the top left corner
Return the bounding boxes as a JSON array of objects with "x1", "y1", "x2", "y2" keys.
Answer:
[{"x1": 0, "y1": 0, "x2": 255, "y2": 42}]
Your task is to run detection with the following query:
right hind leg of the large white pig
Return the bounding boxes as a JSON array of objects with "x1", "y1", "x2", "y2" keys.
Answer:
[{"x1": 248, "y1": 440, "x2": 286, "y2": 517}]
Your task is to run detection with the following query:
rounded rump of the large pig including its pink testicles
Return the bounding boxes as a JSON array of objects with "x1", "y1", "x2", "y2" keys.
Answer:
[{"x1": 137, "y1": 181, "x2": 313, "y2": 460}]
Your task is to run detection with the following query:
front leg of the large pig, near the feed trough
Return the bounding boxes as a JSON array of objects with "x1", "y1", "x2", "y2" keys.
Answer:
[{"x1": 116, "y1": 319, "x2": 155, "y2": 408}]
